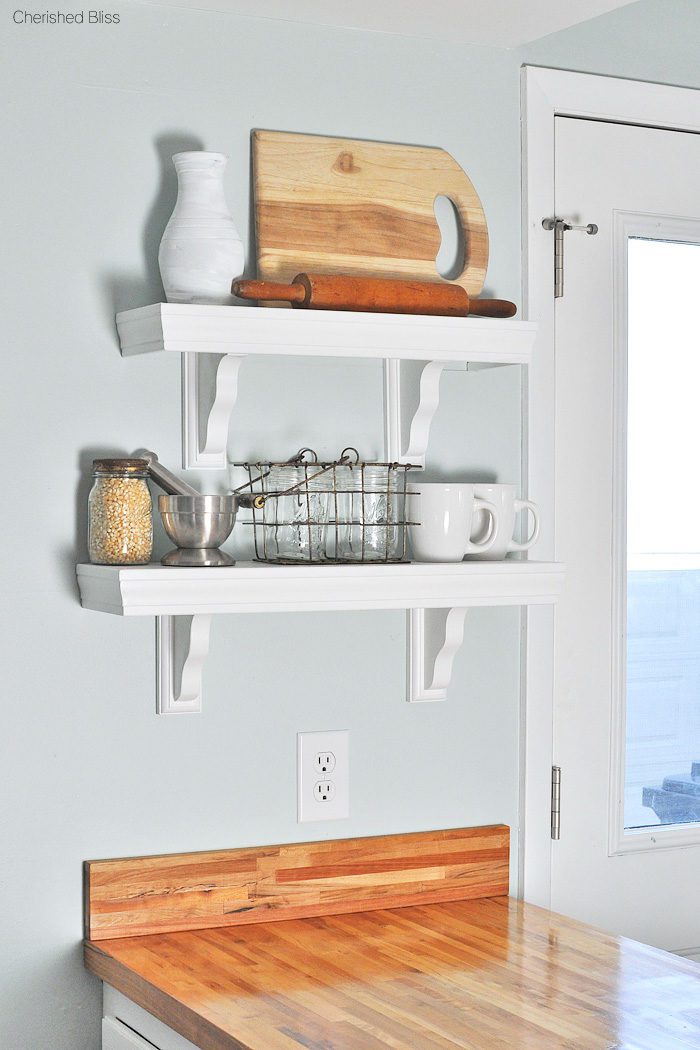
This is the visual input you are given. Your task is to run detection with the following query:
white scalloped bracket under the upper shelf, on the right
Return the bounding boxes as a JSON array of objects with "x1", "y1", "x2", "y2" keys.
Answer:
[{"x1": 384, "y1": 358, "x2": 449, "y2": 466}]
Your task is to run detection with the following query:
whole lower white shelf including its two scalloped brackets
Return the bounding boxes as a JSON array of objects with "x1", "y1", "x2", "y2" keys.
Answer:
[{"x1": 78, "y1": 562, "x2": 564, "y2": 714}]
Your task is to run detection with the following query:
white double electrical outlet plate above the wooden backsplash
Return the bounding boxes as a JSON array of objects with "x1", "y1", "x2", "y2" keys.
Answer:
[{"x1": 297, "y1": 730, "x2": 349, "y2": 823}]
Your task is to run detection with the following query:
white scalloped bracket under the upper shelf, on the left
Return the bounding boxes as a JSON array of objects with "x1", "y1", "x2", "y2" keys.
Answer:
[{"x1": 182, "y1": 351, "x2": 243, "y2": 470}]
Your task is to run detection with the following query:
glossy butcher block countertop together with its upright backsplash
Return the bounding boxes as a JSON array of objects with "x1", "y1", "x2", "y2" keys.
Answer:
[{"x1": 85, "y1": 827, "x2": 700, "y2": 1050}]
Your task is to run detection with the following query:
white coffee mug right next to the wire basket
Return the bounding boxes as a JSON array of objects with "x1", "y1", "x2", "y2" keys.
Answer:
[{"x1": 407, "y1": 482, "x2": 497, "y2": 562}]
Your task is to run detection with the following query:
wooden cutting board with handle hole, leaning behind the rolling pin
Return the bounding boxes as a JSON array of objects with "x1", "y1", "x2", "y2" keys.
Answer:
[{"x1": 253, "y1": 131, "x2": 488, "y2": 296}]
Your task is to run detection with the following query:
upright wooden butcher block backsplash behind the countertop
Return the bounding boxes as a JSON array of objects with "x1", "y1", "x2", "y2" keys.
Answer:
[{"x1": 84, "y1": 825, "x2": 509, "y2": 941}]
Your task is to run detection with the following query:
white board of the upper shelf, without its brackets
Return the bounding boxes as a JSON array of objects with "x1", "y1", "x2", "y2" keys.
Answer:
[{"x1": 116, "y1": 302, "x2": 537, "y2": 364}]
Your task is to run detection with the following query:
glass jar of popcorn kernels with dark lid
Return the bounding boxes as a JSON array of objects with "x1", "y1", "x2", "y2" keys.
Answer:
[{"x1": 87, "y1": 459, "x2": 153, "y2": 565}]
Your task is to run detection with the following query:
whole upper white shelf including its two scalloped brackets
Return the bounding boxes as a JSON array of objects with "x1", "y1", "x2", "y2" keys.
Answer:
[{"x1": 116, "y1": 302, "x2": 537, "y2": 469}]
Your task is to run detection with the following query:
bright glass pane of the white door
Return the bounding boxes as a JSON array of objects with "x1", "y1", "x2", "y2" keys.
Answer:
[{"x1": 624, "y1": 237, "x2": 700, "y2": 831}]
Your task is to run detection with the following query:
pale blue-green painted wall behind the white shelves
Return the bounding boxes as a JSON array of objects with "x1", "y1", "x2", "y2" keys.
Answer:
[{"x1": 0, "y1": 0, "x2": 697, "y2": 1050}]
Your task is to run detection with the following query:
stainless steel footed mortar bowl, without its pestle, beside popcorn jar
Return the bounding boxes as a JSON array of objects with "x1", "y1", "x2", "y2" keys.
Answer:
[{"x1": 158, "y1": 496, "x2": 238, "y2": 565}]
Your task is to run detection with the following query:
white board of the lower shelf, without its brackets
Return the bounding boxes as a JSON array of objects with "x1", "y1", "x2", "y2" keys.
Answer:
[{"x1": 78, "y1": 562, "x2": 564, "y2": 616}]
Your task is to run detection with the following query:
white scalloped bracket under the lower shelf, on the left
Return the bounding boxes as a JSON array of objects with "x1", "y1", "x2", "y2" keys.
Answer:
[{"x1": 155, "y1": 613, "x2": 211, "y2": 715}]
